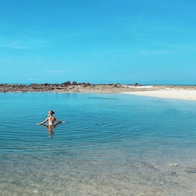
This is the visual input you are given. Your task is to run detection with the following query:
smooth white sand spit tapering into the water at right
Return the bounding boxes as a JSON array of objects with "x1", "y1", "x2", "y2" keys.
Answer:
[{"x1": 125, "y1": 88, "x2": 196, "y2": 101}]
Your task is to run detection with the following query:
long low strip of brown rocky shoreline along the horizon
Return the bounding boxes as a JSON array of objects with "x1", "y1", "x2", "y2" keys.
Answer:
[{"x1": 0, "y1": 81, "x2": 196, "y2": 93}]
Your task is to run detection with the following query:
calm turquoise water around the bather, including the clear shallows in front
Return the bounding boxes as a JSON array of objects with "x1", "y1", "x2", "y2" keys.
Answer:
[{"x1": 0, "y1": 93, "x2": 196, "y2": 196}]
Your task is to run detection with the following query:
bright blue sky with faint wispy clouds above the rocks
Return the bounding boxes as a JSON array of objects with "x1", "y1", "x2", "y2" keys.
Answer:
[{"x1": 0, "y1": 0, "x2": 196, "y2": 84}]
